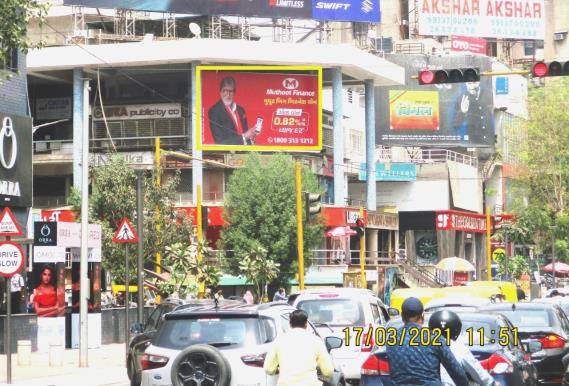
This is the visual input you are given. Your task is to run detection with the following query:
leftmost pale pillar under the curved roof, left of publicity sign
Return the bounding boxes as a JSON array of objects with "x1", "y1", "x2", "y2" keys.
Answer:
[{"x1": 73, "y1": 68, "x2": 84, "y2": 191}]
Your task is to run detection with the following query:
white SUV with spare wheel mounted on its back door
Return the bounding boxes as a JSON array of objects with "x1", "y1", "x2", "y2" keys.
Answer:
[{"x1": 141, "y1": 302, "x2": 345, "y2": 386}]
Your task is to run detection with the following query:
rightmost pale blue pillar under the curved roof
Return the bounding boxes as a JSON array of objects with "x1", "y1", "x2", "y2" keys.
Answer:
[{"x1": 365, "y1": 80, "x2": 377, "y2": 211}]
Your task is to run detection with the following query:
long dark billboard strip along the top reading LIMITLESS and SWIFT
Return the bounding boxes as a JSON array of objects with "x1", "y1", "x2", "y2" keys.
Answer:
[{"x1": 63, "y1": 0, "x2": 380, "y2": 23}]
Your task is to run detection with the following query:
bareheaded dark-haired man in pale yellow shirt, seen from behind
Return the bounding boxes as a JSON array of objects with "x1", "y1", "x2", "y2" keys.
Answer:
[{"x1": 264, "y1": 310, "x2": 334, "y2": 386}]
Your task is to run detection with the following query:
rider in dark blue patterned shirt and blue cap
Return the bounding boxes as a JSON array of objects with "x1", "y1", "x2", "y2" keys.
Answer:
[{"x1": 386, "y1": 297, "x2": 468, "y2": 386}]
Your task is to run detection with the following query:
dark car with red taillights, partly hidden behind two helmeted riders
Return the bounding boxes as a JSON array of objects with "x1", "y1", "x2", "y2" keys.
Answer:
[{"x1": 360, "y1": 311, "x2": 541, "y2": 386}]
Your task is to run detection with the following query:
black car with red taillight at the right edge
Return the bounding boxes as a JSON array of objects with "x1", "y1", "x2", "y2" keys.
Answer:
[{"x1": 480, "y1": 302, "x2": 569, "y2": 385}]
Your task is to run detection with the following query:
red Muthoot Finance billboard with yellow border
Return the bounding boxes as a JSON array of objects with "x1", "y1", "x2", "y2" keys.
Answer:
[{"x1": 195, "y1": 66, "x2": 322, "y2": 151}]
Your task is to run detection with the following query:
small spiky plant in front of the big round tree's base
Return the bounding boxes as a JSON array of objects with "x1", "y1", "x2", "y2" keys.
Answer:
[{"x1": 239, "y1": 243, "x2": 280, "y2": 298}]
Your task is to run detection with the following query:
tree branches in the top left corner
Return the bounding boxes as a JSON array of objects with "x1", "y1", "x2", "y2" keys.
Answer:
[{"x1": 0, "y1": 0, "x2": 49, "y2": 76}]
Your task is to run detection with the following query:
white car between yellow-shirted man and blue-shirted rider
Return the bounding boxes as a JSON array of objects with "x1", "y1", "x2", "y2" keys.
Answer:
[{"x1": 289, "y1": 288, "x2": 398, "y2": 384}]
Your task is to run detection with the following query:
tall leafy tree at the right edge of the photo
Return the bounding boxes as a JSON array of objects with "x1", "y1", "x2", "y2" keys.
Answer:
[{"x1": 509, "y1": 78, "x2": 569, "y2": 258}]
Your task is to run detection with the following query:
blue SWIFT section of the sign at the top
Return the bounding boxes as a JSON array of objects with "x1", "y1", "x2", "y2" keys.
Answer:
[{"x1": 312, "y1": 0, "x2": 381, "y2": 23}]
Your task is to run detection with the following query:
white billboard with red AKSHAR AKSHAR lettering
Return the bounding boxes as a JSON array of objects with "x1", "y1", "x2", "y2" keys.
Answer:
[{"x1": 418, "y1": 0, "x2": 545, "y2": 40}]
